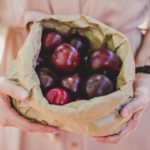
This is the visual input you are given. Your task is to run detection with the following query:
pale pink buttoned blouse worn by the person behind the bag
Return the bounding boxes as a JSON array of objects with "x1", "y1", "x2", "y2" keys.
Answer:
[{"x1": 0, "y1": 0, "x2": 150, "y2": 150}]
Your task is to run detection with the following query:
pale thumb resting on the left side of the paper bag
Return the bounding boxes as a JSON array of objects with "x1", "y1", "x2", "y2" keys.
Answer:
[{"x1": 0, "y1": 77, "x2": 29, "y2": 100}]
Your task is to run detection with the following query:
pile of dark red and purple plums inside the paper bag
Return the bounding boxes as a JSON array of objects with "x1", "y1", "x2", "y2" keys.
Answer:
[{"x1": 36, "y1": 28, "x2": 122, "y2": 105}]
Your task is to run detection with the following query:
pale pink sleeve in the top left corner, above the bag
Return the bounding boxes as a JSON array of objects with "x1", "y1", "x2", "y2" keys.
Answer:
[{"x1": 0, "y1": 0, "x2": 50, "y2": 28}]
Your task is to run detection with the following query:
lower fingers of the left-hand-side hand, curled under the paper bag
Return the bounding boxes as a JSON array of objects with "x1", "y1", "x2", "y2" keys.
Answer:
[{"x1": 10, "y1": 109, "x2": 59, "y2": 133}]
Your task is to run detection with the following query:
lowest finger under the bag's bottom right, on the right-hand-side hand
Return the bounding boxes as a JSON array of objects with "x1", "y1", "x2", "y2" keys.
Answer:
[{"x1": 96, "y1": 119, "x2": 137, "y2": 144}]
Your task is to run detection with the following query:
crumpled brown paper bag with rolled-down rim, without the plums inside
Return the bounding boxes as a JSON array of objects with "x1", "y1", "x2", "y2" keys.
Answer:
[{"x1": 8, "y1": 16, "x2": 135, "y2": 136}]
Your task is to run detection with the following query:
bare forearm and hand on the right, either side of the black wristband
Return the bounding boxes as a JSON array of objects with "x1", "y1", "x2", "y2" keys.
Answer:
[{"x1": 94, "y1": 27, "x2": 150, "y2": 144}]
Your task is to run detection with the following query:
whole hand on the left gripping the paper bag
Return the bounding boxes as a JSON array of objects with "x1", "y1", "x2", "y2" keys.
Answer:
[{"x1": 0, "y1": 77, "x2": 59, "y2": 132}]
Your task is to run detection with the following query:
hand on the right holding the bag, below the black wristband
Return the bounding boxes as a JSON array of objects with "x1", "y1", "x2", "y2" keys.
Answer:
[{"x1": 94, "y1": 73, "x2": 150, "y2": 144}]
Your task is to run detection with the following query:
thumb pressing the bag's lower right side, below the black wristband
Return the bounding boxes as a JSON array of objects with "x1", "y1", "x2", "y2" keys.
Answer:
[{"x1": 120, "y1": 97, "x2": 147, "y2": 117}]
